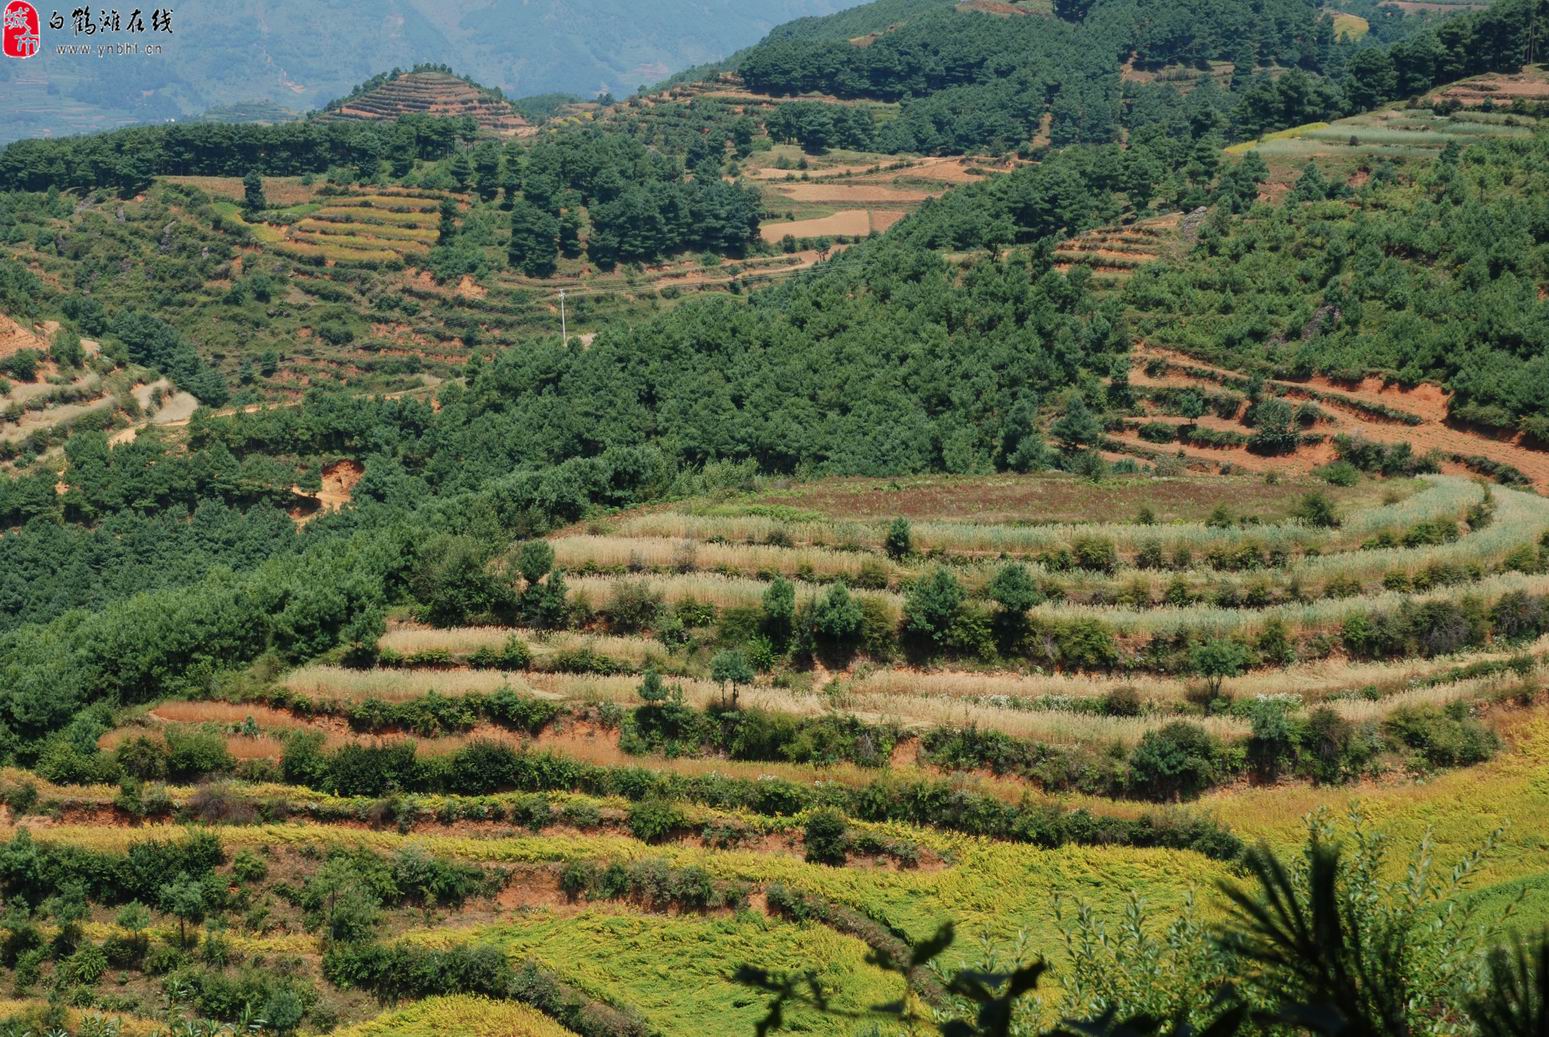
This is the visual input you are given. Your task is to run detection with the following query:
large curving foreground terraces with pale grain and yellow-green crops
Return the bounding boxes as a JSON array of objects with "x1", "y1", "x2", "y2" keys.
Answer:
[{"x1": 12, "y1": 474, "x2": 1549, "y2": 1037}]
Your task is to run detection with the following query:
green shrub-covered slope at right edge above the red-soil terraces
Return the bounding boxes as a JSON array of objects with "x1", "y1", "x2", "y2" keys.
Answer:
[{"x1": 1129, "y1": 128, "x2": 1549, "y2": 427}]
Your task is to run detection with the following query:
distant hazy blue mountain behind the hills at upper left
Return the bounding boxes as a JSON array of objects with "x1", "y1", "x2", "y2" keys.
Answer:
[{"x1": 0, "y1": 0, "x2": 853, "y2": 140}]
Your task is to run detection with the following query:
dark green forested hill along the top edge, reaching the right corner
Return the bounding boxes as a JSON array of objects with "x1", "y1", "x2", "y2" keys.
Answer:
[{"x1": 737, "y1": 0, "x2": 1537, "y2": 153}]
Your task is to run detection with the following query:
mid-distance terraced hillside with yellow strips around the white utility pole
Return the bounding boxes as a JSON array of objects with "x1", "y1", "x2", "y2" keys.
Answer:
[{"x1": 166, "y1": 177, "x2": 826, "y2": 401}]
